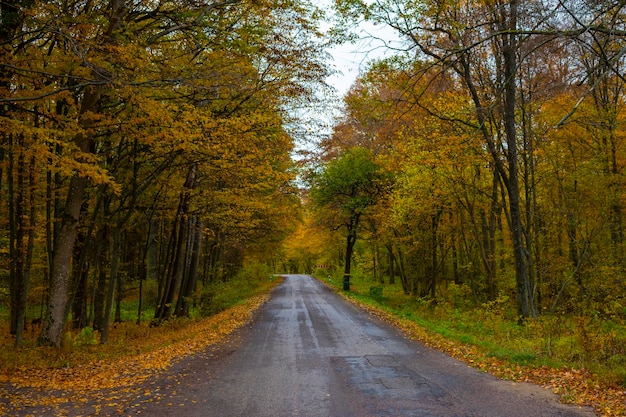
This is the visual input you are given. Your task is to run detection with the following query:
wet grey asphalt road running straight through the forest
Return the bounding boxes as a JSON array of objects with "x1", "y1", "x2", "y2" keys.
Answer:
[{"x1": 125, "y1": 275, "x2": 594, "y2": 417}]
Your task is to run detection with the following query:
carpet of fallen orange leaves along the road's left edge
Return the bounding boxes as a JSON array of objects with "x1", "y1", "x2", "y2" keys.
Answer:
[{"x1": 0, "y1": 282, "x2": 276, "y2": 415}]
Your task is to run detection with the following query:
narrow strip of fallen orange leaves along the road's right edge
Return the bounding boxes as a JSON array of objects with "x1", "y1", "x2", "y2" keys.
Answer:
[{"x1": 339, "y1": 286, "x2": 626, "y2": 417}]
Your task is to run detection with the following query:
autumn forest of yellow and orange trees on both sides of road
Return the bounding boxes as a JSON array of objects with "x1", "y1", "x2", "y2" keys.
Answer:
[{"x1": 0, "y1": 0, "x2": 626, "y2": 412}]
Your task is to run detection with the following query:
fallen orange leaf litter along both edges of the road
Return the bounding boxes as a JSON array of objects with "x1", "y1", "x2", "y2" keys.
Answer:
[{"x1": 0, "y1": 278, "x2": 626, "y2": 417}]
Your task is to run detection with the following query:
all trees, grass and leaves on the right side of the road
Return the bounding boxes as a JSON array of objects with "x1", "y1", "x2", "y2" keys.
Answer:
[{"x1": 290, "y1": 0, "x2": 626, "y2": 415}]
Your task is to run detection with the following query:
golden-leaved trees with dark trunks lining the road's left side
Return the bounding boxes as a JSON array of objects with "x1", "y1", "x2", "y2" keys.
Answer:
[{"x1": 0, "y1": 0, "x2": 327, "y2": 346}]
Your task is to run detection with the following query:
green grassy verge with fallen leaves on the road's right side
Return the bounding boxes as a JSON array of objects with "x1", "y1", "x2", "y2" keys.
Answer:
[{"x1": 323, "y1": 275, "x2": 626, "y2": 416}]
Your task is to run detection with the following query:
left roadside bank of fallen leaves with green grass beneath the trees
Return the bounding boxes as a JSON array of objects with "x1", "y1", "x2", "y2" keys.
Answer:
[{"x1": 0, "y1": 271, "x2": 281, "y2": 415}]
